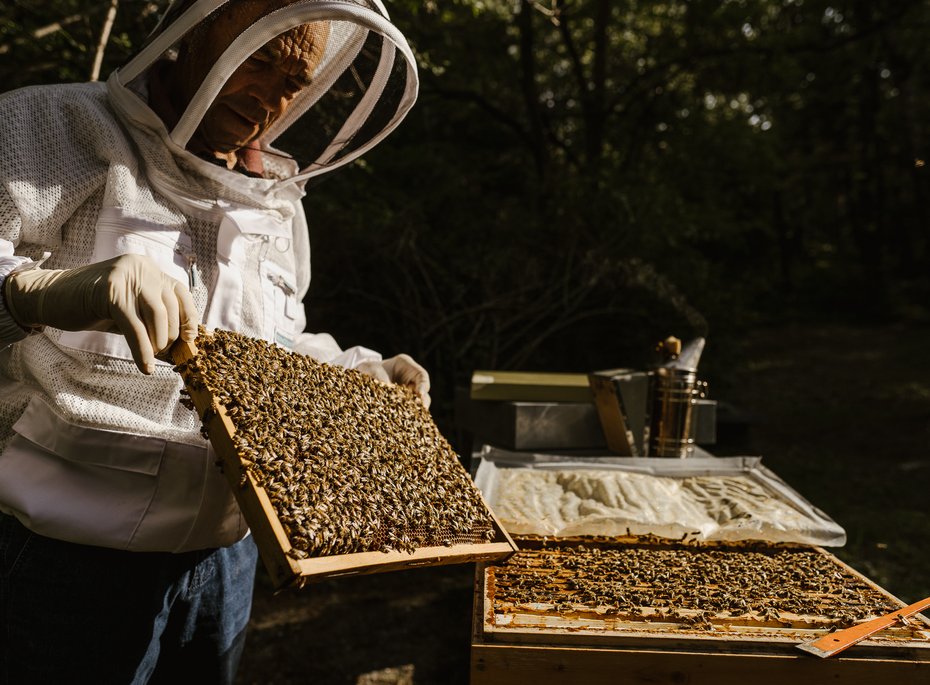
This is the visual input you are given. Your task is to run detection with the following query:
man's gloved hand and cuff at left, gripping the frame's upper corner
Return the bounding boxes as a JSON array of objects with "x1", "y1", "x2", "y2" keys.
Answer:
[{"x1": 4, "y1": 254, "x2": 200, "y2": 374}]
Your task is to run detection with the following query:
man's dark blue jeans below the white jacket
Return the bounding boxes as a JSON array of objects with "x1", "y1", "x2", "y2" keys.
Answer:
[{"x1": 0, "y1": 514, "x2": 258, "y2": 685}]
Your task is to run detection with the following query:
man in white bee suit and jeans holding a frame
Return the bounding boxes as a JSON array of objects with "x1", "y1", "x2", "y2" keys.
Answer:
[{"x1": 0, "y1": 0, "x2": 429, "y2": 683}]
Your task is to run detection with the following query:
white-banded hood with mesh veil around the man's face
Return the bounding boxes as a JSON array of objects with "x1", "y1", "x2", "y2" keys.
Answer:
[{"x1": 108, "y1": 0, "x2": 418, "y2": 191}]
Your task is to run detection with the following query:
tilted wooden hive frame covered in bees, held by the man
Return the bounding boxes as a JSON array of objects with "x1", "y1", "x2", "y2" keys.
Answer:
[{"x1": 172, "y1": 330, "x2": 516, "y2": 587}]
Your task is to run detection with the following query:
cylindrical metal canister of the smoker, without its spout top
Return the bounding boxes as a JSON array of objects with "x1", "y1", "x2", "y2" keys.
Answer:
[{"x1": 649, "y1": 367, "x2": 707, "y2": 458}]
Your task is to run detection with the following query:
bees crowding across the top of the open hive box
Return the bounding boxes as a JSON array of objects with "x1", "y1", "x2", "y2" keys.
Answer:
[{"x1": 489, "y1": 541, "x2": 899, "y2": 630}]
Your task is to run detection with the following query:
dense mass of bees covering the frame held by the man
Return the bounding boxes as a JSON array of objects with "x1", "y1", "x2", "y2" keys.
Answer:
[{"x1": 177, "y1": 329, "x2": 494, "y2": 558}]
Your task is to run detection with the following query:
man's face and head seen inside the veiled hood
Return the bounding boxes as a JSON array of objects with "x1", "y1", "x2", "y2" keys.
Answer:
[{"x1": 177, "y1": 0, "x2": 329, "y2": 155}]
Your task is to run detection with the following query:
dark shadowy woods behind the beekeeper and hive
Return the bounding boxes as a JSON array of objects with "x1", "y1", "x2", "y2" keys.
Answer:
[{"x1": 0, "y1": 0, "x2": 930, "y2": 616}]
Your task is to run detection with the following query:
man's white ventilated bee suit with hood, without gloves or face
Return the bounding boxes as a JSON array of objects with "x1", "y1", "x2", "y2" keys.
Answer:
[{"x1": 0, "y1": 0, "x2": 417, "y2": 552}]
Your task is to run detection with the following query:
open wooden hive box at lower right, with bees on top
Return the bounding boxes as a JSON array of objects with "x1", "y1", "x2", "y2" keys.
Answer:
[{"x1": 472, "y1": 537, "x2": 930, "y2": 685}]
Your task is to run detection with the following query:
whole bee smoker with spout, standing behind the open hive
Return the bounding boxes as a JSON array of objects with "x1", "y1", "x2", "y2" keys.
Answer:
[{"x1": 648, "y1": 337, "x2": 707, "y2": 458}]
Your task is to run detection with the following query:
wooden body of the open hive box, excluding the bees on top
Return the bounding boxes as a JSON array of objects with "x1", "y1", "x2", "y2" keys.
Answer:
[{"x1": 472, "y1": 538, "x2": 930, "y2": 685}]
